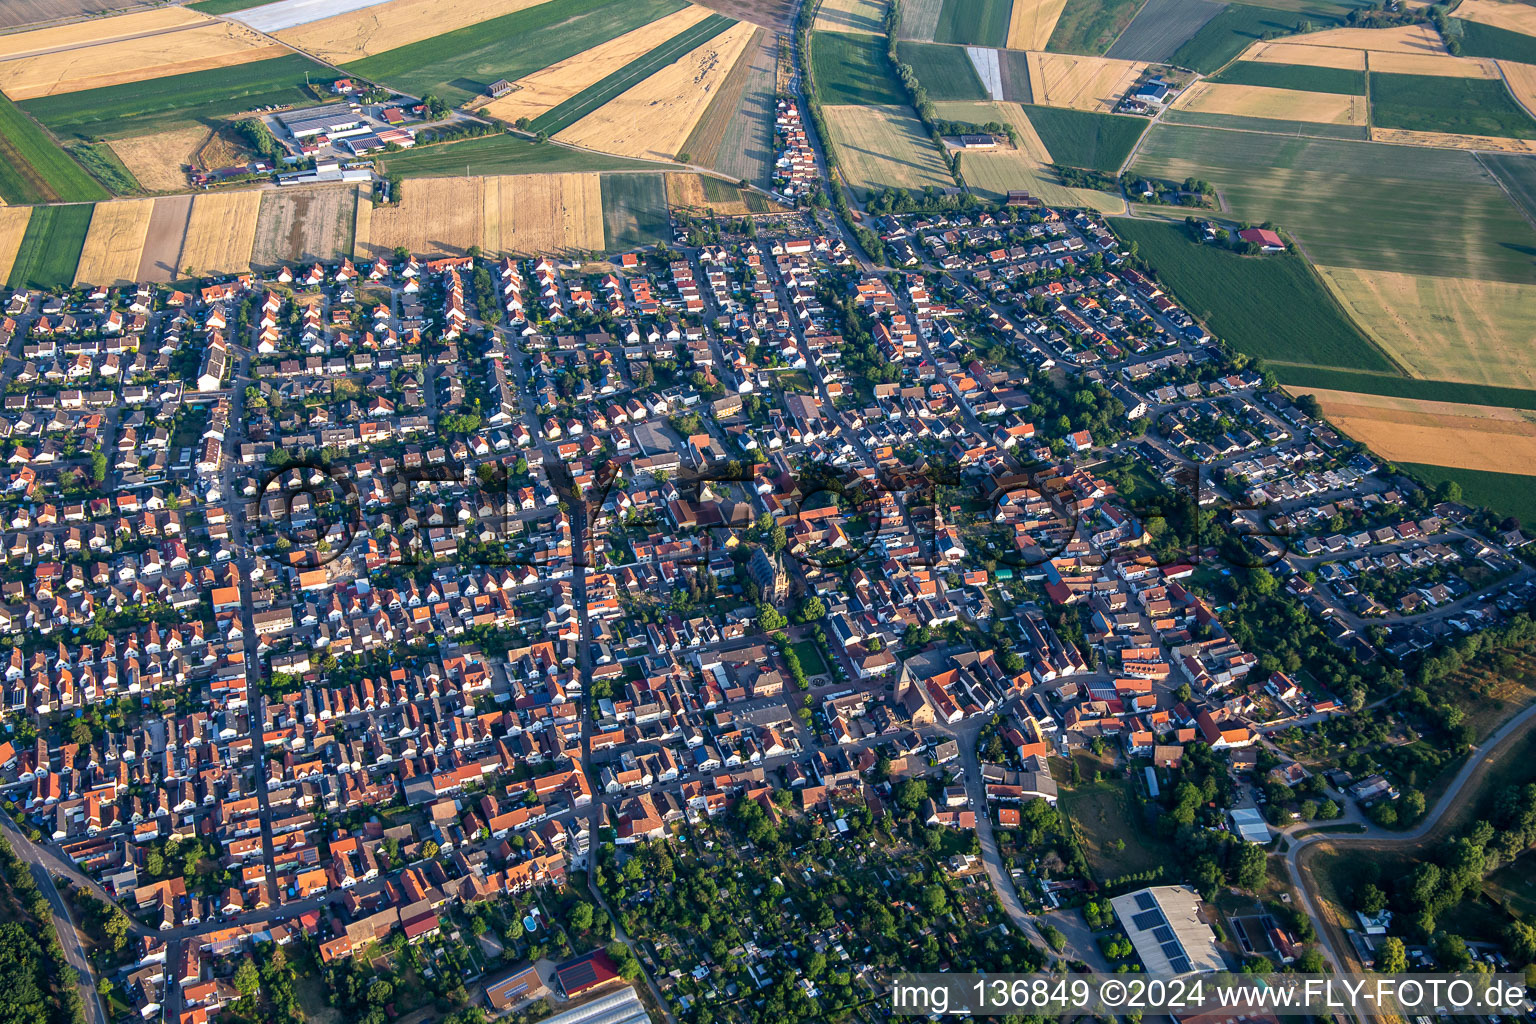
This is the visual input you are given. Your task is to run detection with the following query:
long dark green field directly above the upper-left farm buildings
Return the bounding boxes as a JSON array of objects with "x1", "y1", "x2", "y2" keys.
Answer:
[{"x1": 22, "y1": 54, "x2": 336, "y2": 141}]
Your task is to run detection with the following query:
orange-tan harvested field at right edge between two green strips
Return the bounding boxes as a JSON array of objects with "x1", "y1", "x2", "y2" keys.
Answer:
[{"x1": 1306, "y1": 388, "x2": 1536, "y2": 476}]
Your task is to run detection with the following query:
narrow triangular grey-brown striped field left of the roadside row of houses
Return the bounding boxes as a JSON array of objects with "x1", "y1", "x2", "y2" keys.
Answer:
[{"x1": 682, "y1": 29, "x2": 779, "y2": 187}]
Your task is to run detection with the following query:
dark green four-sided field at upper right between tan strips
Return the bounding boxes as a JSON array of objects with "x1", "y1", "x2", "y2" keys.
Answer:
[{"x1": 1370, "y1": 72, "x2": 1536, "y2": 138}]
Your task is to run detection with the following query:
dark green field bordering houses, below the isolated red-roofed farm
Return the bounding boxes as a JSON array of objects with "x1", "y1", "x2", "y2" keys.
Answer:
[{"x1": 1109, "y1": 218, "x2": 1393, "y2": 372}]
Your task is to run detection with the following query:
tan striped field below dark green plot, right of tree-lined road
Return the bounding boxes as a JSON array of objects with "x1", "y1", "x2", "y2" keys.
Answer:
[{"x1": 822, "y1": 106, "x2": 954, "y2": 192}]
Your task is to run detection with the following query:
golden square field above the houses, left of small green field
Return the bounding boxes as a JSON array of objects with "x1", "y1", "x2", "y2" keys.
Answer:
[{"x1": 481, "y1": 173, "x2": 604, "y2": 256}]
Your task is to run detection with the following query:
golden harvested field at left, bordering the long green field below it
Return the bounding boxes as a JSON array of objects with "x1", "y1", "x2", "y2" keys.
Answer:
[{"x1": 0, "y1": 15, "x2": 289, "y2": 100}]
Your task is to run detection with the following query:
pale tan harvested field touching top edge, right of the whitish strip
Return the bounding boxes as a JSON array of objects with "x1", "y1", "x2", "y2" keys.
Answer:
[{"x1": 275, "y1": 0, "x2": 547, "y2": 64}]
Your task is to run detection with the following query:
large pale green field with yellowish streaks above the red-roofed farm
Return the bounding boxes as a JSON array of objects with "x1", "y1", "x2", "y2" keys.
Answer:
[{"x1": 1124, "y1": 124, "x2": 1536, "y2": 282}]
